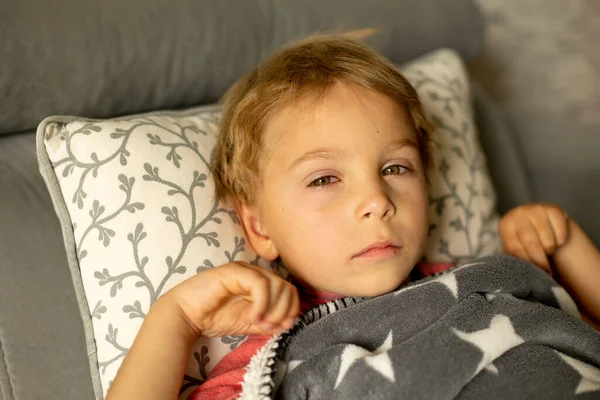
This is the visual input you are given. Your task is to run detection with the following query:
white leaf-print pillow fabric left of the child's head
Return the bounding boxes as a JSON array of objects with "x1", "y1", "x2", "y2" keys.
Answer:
[{"x1": 44, "y1": 107, "x2": 258, "y2": 393}]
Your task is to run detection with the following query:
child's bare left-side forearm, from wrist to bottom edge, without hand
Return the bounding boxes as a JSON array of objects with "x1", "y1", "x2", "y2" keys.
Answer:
[{"x1": 106, "y1": 298, "x2": 196, "y2": 400}]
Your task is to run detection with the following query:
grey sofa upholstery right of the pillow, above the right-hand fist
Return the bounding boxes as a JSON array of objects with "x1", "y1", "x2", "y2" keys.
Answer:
[{"x1": 473, "y1": 82, "x2": 600, "y2": 246}]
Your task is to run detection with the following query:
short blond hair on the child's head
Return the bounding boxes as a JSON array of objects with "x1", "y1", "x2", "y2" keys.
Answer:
[{"x1": 213, "y1": 31, "x2": 431, "y2": 205}]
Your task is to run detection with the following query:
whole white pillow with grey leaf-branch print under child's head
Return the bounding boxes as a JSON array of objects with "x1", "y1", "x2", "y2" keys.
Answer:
[{"x1": 38, "y1": 50, "x2": 500, "y2": 398}]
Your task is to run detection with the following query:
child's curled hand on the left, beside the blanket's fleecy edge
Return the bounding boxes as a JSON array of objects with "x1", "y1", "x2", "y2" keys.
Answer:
[{"x1": 165, "y1": 262, "x2": 300, "y2": 337}]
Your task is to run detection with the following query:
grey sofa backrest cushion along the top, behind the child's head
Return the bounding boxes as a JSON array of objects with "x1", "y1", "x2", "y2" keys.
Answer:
[{"x1": 0, "y1": 0, "x2": 483, "y2": 133}]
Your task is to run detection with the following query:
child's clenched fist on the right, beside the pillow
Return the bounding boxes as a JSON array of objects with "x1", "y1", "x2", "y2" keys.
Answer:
[{"x1": 498, "y1": 204, "x2": 569, "y2": 274}]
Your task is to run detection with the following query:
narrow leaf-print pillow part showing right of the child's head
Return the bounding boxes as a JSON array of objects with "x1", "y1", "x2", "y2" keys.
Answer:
[{"x1": 403, "y1": 50, "x2": 500, "y2": 264}]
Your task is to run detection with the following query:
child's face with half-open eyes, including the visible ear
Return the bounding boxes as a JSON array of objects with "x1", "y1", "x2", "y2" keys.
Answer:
[{"x1": 240, "y1": 84, "x2": 428, "y2": 296}]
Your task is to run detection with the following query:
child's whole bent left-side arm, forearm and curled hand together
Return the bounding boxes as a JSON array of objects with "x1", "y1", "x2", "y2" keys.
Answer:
[{"x1": 106, "y1": 262, "x2": 300, "y2": 400}]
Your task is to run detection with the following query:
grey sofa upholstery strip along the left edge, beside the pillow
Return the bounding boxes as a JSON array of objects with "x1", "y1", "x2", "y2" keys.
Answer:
[{"x1": 0, "y1": 132, "x2": 93, "y2": 400}]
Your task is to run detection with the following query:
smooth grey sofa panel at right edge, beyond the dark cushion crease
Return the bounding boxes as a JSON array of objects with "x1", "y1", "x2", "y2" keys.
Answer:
[{"x1": 505, "y1": 110, "x2": 600, "y2": 246}]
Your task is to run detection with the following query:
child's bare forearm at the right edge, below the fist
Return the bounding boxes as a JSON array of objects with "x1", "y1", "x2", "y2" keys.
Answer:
[{"x1": 553, "y1": 220, "x2": 600, "y2": 326}]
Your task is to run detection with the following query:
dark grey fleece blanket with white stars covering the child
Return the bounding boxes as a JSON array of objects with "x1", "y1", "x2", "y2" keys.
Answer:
[{"x1": 241, "y1": 256, "x2": 600, "y2": 400}]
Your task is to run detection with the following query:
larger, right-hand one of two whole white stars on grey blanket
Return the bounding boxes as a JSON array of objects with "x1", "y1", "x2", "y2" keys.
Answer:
[{"x1": 453, "y1": 314, "x2": 524, "y2": 376}]
